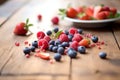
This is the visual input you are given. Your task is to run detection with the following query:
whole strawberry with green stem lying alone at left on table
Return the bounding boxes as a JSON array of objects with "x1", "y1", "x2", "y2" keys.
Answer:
[{"x1": 13, "y1": 19, "x2": 33, "y2": 35}]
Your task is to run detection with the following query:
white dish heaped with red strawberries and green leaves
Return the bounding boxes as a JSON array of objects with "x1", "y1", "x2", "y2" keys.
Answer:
[{"x1": 59, "y1": 5, "x2": 120, "y2": 28}]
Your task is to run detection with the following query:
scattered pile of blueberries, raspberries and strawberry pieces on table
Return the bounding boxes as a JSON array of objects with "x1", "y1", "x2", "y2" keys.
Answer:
[{"x1": 15, "y1": 27, "x2": 106, "y2": 61}]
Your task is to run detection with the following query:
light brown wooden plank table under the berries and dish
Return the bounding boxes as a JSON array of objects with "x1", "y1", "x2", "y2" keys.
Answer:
[{"x1": 0, "y1": 0, "x2": 120, "y2": 80}]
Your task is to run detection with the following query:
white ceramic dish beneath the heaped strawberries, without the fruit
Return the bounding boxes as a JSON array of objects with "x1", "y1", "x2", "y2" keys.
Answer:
[{"x1": 65, "y1": 17, "x2": 120, "y2": 28}]
